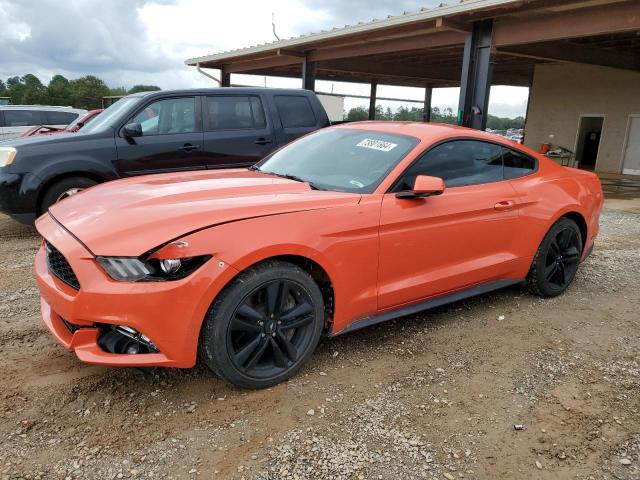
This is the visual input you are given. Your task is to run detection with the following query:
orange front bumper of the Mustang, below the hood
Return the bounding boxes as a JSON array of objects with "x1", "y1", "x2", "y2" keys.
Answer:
[{"x1": 35, "y1": 214, "x2": 237, "y2": 368}]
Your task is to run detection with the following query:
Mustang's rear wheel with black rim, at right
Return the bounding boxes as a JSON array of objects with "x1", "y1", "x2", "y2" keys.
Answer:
[{"x1": 527, "y1": 217, "x2": 582, "y2": 297}]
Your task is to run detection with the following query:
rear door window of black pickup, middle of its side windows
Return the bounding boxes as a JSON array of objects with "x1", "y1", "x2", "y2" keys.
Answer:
[{"x1": 206, "y1": 95, "x2": 266, "y2": 131}]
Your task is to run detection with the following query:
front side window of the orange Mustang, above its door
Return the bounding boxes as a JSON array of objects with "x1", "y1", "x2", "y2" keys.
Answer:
[{"x1": 400, "y1": 140, "x2": 503, "y2": 190}]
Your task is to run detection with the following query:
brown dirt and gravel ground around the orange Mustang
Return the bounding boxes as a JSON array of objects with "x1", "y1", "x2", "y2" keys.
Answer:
[{"x1": 0, "y1": 196, "x2": 640, "y2": 480}]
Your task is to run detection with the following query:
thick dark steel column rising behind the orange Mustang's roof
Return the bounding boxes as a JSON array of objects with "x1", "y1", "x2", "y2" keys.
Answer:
[{"x1": 458, "y1": 20, "x2": 493, "y2": 130}]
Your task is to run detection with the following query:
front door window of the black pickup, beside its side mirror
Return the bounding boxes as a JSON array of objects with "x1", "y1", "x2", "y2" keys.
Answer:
[{"x1": 132, "y1": 97, "x2": 199, "y2": 136}]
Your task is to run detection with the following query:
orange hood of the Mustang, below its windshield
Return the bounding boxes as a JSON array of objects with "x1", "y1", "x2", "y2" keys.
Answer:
[{"x1": 49, "y1": 170, "x2": 360, "y2": 256}]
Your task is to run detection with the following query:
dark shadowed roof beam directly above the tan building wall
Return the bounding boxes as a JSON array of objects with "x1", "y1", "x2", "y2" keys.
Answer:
[{"x1": 498, "y1": 42, "x2": 640, "y2": 70}]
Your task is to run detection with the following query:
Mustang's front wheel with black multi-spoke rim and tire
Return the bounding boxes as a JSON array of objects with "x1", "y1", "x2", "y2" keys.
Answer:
[{"x1": 199, "y1": 260, "x2": 324, "y2": 389}]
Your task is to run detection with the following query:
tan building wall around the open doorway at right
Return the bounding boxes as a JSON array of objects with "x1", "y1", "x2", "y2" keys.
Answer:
[{"x1": 525, "y1": 64, "x2": 640, "y2": 173}]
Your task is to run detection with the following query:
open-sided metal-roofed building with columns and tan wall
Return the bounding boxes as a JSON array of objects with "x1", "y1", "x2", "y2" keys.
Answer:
[{"x1": 185, "y1": 0, "x2": 640, "y2": 174}]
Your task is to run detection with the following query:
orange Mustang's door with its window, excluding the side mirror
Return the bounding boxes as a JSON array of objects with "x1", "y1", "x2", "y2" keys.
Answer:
[{"x1": 378, "y1": 140, "x2": 518, "y2": 309}]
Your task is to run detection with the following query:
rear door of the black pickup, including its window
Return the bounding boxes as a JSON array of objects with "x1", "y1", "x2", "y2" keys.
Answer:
[{"x1": 203, "y1": 94, "x2": 276, "y2": 168}]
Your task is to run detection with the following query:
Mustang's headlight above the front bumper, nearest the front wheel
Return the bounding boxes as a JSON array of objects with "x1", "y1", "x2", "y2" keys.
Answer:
[{"x1": 97, "y1": 255, "x2": 211, "y2": 282}]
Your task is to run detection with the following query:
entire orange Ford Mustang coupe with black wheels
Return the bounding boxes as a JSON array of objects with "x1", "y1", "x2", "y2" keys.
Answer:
[{"x1": 35, "y1": 122, "x2": 603, "y2": 388}]
